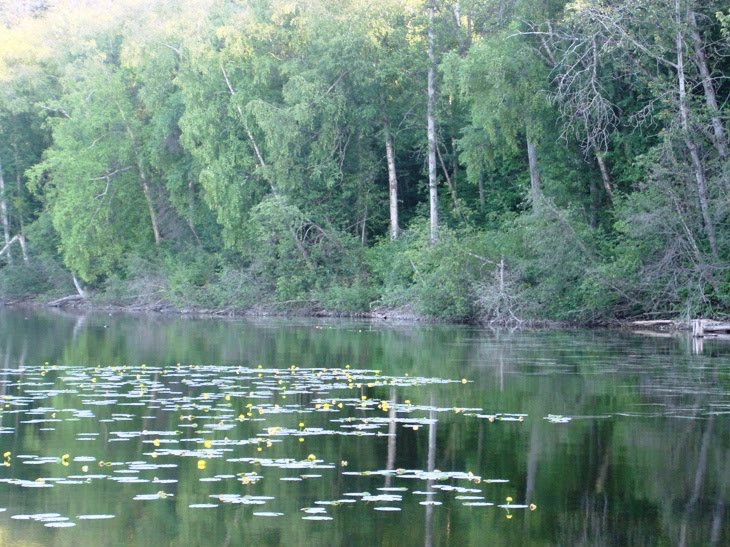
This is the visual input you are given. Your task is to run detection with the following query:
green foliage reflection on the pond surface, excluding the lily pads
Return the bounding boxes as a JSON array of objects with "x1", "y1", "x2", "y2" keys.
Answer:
[{"x1": 0, "y1": 311, "x2": 730, "y2": 544}]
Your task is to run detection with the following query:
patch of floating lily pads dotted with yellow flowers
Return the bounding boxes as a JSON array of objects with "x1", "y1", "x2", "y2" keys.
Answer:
[{"x1": 0, "y1": 363, "x2": 536, "y2": 528}]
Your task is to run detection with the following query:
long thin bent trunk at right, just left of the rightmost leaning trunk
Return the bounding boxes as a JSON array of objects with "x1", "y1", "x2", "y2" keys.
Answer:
[{"x1": 674, "y1": 0, "x2": 717, "y2": 259}]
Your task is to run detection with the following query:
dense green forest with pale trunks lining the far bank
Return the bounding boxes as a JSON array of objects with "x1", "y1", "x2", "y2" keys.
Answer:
[{"x1": 0, "y1": 0, "x2": 730, "y2": 324}]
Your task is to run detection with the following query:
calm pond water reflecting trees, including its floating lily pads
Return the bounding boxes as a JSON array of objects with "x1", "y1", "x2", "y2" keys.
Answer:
[{"x1": 0, "y1": 310, "x2": 730, "y2": 546}]
